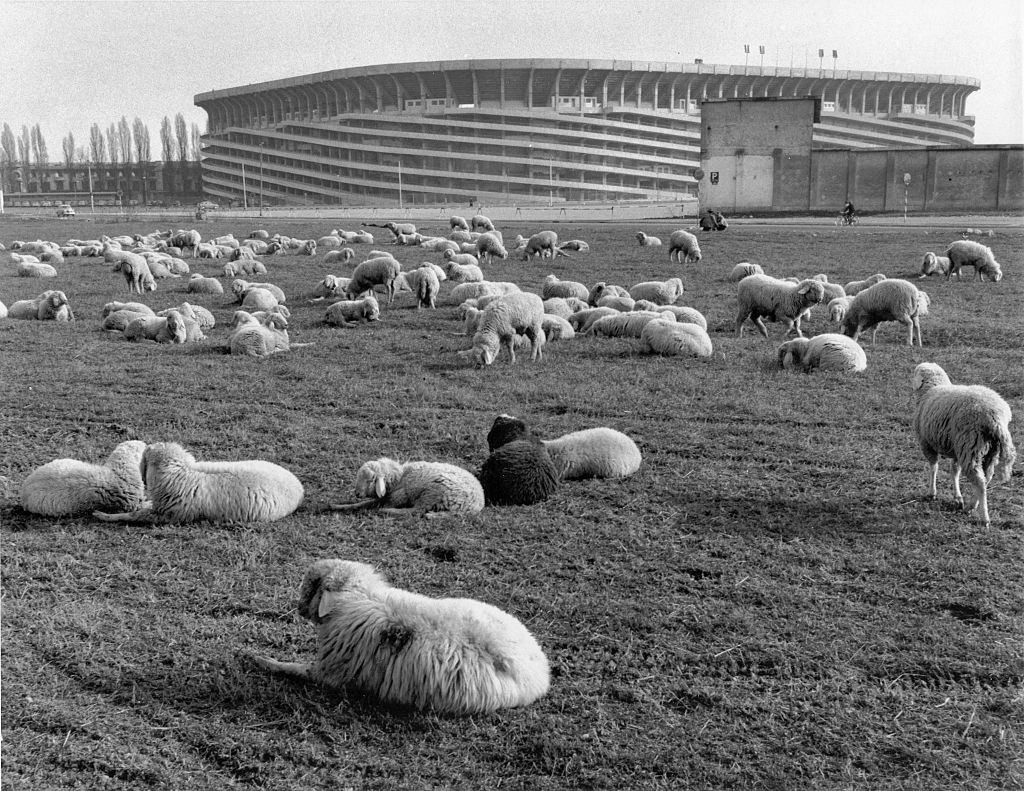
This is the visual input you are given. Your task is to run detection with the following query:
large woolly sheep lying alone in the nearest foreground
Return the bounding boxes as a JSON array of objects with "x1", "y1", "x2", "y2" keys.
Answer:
[{"x1": 253, "y1": 559, "x2": 550, "y2": 714}]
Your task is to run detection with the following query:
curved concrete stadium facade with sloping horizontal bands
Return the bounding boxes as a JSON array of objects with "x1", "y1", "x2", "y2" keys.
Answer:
[{"x1": 195, "y1": 59, "x2": 980, "y2": 206}]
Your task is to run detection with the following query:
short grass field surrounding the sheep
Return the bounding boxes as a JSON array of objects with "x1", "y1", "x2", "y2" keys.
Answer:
[{"x1": 0, "y1": 213, "x2": 1024, "y2": 791}]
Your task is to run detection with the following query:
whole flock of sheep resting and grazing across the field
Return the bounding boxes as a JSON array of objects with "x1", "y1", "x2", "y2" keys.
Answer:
[{"x1": 0, "y1": 216, "x2": 1016, "y2": 713}]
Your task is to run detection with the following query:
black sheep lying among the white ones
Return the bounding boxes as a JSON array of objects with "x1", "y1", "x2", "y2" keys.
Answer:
[{"x1": 479, "y1": 415, "x2": 560, "y2": 505}]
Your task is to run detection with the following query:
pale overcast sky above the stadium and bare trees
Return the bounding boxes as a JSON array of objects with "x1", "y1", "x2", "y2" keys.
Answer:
[{"x1": 0, "y1": 0, "x2": 1024, "y2": 156}]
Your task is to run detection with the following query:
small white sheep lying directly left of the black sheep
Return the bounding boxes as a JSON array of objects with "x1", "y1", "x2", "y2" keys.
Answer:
[{"x1": 331, "y1": 457, "x2": 483, "y2": 517}]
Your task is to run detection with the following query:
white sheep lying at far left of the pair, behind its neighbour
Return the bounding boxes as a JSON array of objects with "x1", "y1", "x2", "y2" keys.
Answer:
[{"x1": 22, "y1": 440, "x2": 145, "y2": 516}]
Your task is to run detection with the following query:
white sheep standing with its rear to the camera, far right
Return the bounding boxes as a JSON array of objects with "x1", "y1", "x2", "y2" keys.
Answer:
[{"x1": 911, "y1": 363, "x2": 1017, "y2": 527}]
